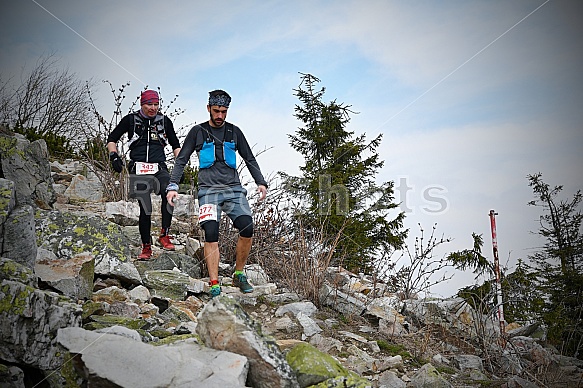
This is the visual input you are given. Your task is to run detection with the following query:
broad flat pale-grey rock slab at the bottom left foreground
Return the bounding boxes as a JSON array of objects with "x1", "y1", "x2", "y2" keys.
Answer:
[{"x1": 57, "y1": 328, "x2": 249, "y2": 388}]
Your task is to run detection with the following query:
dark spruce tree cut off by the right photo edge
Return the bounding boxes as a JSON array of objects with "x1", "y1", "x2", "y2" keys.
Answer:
[{"x1": 527, "y1": 173, "x2": 583, "y2": 357}]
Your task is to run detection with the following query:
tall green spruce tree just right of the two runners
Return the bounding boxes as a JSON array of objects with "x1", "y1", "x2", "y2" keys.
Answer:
[{"x1": 282, "y1": 74, "x2": 407, "y2": 272}]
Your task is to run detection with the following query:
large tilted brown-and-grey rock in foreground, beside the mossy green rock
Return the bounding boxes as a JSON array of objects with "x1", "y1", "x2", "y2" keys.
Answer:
[{"x1": 196, "y1": 296, "x2": 298, "y2": 388}]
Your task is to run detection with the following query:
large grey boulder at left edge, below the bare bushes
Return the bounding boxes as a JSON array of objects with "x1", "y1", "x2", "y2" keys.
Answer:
[{"x1": 0, "y1": 128, "x2": 56, "y2": 209}]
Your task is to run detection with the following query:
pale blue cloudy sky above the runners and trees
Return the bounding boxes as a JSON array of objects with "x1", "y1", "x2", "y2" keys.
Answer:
[{"x1": 0, "y1": 0, "x2": 583, "y2": 296}]
